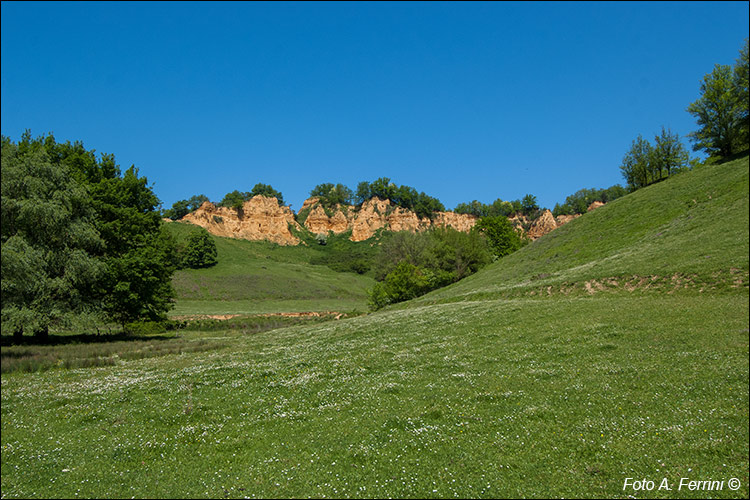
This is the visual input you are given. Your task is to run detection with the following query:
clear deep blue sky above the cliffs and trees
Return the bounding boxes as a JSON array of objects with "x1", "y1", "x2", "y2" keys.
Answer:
[{"x1": 0, "y1": 1, "x2": 748, "y2": 211}]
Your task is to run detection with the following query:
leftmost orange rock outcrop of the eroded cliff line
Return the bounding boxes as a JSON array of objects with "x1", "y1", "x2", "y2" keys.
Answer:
[{"x1": 182, "y1": 195, "x2": 302, "y2": 245}]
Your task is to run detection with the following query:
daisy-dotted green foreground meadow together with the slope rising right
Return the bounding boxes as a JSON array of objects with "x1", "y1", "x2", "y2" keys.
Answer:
[{"x1": 2, "y1": 157, "x2": 750, "y2": 498}]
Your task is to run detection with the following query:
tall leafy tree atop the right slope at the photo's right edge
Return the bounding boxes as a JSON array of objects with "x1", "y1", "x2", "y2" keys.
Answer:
[{"x1": 687, "y1": 64, "x2": 747, "y2": 158}]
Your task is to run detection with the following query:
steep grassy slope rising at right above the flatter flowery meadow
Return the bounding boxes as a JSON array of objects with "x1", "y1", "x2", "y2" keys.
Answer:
[{"x1": 411, "y1": 156, "x2": 750, "y2": 305}]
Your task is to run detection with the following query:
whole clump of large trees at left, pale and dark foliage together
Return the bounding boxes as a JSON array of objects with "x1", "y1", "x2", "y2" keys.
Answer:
[{"x1": 2, "y1": 132, "x2": 175, "y2": 335}]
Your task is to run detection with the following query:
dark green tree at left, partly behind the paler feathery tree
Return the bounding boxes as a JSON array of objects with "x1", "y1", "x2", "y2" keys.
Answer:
[{"x1": 44, "y1": 135, "x2": 176, "y2": 326}]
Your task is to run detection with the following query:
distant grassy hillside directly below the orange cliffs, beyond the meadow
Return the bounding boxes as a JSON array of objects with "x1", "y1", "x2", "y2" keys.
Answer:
[{"x1": 167, "y1": 222, "x2": 374, "y2": 315}]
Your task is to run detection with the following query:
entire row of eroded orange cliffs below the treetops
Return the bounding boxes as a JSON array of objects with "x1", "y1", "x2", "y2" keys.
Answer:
[{"x1": 182, "y1": 195, "x2": 600, "y2": 245}]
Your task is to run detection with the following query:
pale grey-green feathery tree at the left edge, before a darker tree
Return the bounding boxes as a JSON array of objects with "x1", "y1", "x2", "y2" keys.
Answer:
[{"x1": 1, "y1": 132, "x2": 105, "y2": 339}]
